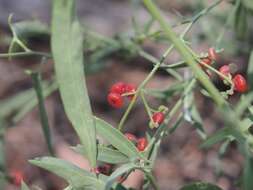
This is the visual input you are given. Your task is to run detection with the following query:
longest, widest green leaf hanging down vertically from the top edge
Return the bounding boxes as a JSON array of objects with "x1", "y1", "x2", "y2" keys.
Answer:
[{"x1": 51, "y1": 0, "x2": 97, "y2": 167}]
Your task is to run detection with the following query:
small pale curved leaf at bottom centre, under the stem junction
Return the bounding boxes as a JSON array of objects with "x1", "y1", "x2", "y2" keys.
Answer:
[{"x1": 105, "y1": 163, "x2": 137, "y2": 190}]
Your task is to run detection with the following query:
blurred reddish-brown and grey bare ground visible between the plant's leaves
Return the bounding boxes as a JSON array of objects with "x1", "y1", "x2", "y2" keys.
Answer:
[{"x1": 0, "y1": 0, "x2": 251, "y2": 190}]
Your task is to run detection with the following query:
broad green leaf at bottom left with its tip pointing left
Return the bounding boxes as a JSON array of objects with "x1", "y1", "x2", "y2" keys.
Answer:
[{"x1": 29, "y1": 157, "x2": 105, "y2": 190}]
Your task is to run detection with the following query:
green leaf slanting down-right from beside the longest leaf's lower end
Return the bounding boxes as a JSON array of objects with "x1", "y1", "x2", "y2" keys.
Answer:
[{"x1": 95, "y1": 117, "x2": 141, "y2": 158}]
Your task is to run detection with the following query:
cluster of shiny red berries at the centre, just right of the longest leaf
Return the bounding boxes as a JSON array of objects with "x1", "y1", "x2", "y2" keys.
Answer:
[{"x1": 107, "y1": 82, "x2": 136, "y2": 108}]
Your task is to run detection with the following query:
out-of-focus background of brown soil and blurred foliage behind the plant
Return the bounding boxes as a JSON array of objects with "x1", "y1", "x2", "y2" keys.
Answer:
[{"x1": 0, "y1": 0, "x2": 253, "y2": 190}]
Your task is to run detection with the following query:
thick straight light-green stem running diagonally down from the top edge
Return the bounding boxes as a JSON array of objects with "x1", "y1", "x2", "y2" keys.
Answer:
[{"x1": 143, "y1": 0, "x2": 226, "y2": 106}]
